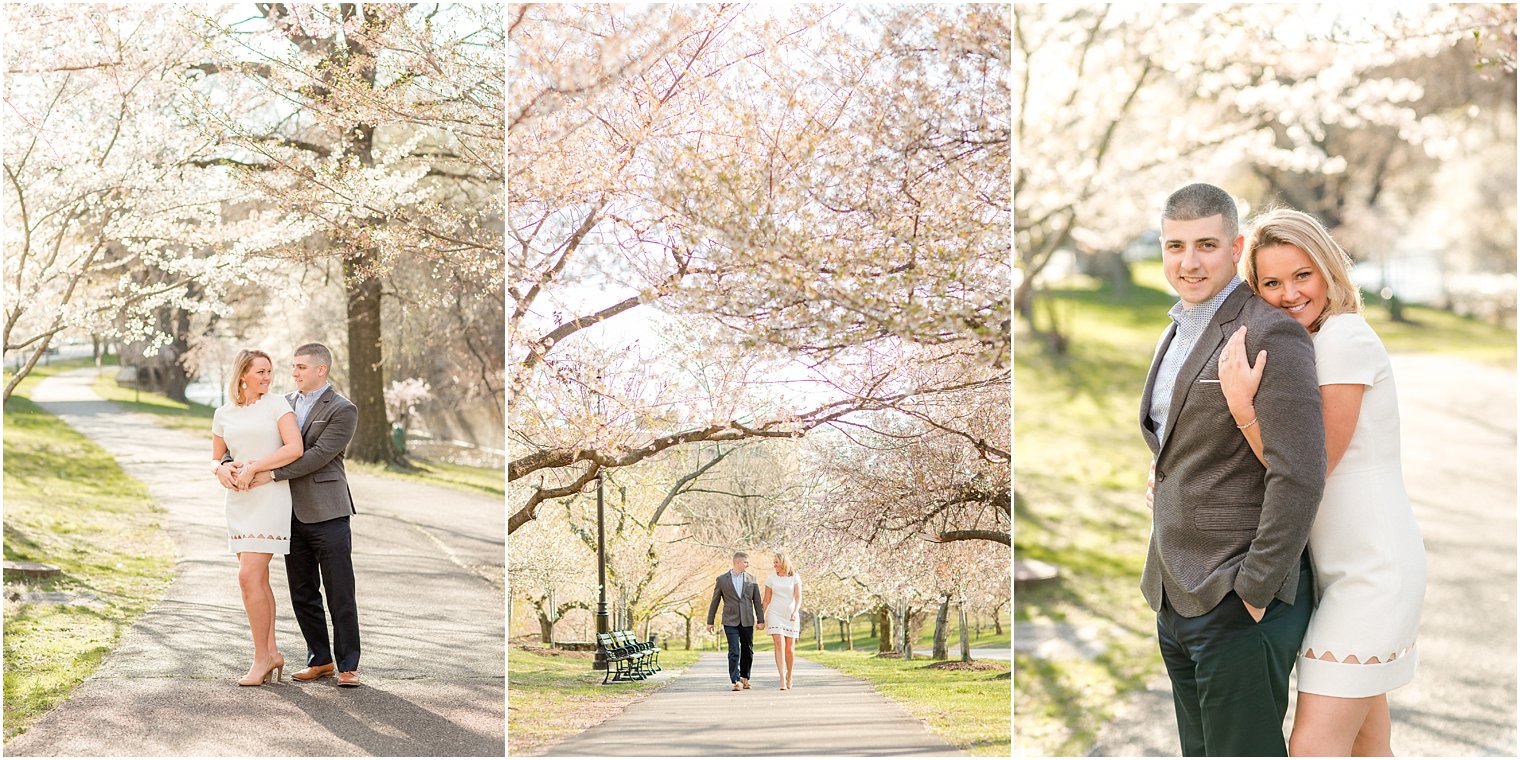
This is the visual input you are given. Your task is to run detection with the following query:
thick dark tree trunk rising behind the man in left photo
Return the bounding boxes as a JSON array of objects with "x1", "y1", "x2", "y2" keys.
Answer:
[{"x1": 344, "y1": 248, "x2": 398, "y2": 462}]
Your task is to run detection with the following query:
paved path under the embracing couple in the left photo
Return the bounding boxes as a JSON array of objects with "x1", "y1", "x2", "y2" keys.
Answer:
[{"x1": 5, "y1": 369, "x2": 506, "y2": 757}]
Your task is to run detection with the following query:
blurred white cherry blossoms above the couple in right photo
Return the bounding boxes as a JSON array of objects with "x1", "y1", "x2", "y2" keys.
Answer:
[{"x1": 1012, "y1": 5, "x2": 1514, "y2": 324}]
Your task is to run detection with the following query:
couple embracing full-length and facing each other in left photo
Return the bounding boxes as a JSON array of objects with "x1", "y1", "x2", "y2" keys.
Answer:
[{"x1": 211, "y1": 344, "x2": 359, "y2": 687}]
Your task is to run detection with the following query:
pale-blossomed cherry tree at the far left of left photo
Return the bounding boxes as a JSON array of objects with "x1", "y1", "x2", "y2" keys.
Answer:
[{"x1": 3, "y1": 5, "x2": 249, "y2": 398}]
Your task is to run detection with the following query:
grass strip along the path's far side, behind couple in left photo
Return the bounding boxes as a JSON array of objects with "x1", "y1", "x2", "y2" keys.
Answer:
[{"x1": 81, "y1": 366, "x2": 506, "y2": 496}]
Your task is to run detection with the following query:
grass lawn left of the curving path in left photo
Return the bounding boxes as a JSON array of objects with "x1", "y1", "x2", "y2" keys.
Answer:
[{"x1": 5, "y1": 363, "x2": 173, "y2": 739}]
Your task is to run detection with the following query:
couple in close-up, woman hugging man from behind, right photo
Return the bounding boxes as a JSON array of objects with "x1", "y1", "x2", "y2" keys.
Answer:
[{"x1": 1140, "y1": 184, "x2": 1426, "y2": 755}]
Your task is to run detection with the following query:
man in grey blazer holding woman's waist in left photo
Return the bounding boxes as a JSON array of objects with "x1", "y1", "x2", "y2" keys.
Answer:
[{"x1": 217, "y1": 344, "x2": 359, "y2": 687}]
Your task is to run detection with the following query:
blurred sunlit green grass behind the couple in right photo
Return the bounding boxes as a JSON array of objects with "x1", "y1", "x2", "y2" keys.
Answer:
[{"x1": 1014, "y1": 261, "x2": 1515, "y2": 755}]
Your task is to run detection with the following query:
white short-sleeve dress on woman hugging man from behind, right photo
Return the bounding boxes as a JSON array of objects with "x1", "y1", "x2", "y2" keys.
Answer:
[{"x1": 1298, "y1": 313, "x2": 1426, "y2": 698}]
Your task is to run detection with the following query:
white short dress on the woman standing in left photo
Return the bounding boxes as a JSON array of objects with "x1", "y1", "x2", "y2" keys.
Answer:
[{"x1": 211, "y1": 394, "x2": 295, "y2": 555}]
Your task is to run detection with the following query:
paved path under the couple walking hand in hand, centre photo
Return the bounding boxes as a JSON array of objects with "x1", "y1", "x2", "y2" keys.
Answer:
[{"x1": 538, "y1": 652, "x2": 962, "y2": 757}]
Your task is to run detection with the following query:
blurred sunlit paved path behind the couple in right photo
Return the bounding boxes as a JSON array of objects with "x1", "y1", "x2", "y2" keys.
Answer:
[{"x1": 1090, "y1": 354, "x2": 1515, "y2": 757}]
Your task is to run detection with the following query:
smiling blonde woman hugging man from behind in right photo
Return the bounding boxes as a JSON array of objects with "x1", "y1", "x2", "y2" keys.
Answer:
[{"x1": 1219, "y1": 208, "x2": 1426, "y2": 757}]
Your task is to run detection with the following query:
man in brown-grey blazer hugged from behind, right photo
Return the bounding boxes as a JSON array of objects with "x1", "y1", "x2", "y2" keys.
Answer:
[{"x1": 1140, "y1": 184, "x2": 1325, "y2": 757}]
